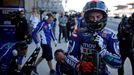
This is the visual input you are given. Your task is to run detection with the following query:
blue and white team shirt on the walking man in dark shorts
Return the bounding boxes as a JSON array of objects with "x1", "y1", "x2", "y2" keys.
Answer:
[{"x1": 32, "y1": 21, "x2": 56, "y2": 45}]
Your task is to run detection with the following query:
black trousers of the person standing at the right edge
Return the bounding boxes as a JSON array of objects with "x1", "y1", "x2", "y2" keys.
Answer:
[{"x1": 118, "y1": 40, "x2": 134, "y2": 75}]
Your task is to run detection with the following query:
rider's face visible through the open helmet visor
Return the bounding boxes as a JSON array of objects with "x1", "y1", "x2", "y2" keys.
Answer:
[{"x1": 89, "y1": 12, "x2": 103, "y2": 22}]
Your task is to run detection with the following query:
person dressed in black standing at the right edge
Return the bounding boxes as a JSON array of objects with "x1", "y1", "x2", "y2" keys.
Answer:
[{"x1": 117, "y1": 13, "x2": 134, "y2": 75}]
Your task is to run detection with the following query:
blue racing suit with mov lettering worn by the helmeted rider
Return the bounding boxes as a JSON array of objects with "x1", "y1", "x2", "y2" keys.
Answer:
[{"x1": 67, "y1": 28, "x2": 121, "y2": 75}]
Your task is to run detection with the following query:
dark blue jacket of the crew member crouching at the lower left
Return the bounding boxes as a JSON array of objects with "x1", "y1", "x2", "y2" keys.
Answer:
[{"x1": 0, "y1": 42, "x2": 24, "y2": 75}]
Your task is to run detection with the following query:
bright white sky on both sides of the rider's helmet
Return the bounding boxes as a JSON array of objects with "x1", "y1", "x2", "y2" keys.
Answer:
[{"x1": 63, "y1": 0, "x2": 134, "y2": 11}]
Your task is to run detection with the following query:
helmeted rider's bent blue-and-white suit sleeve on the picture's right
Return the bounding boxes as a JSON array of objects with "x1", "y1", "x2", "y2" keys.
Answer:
[{"x1": 100, "y1": 29, "x2": 122, "y2": 68}]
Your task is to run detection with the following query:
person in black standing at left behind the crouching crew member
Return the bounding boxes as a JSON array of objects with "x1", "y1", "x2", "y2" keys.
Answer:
[{"x1": 14, "y1": 10, "x2": 29, "y2": 41}]
